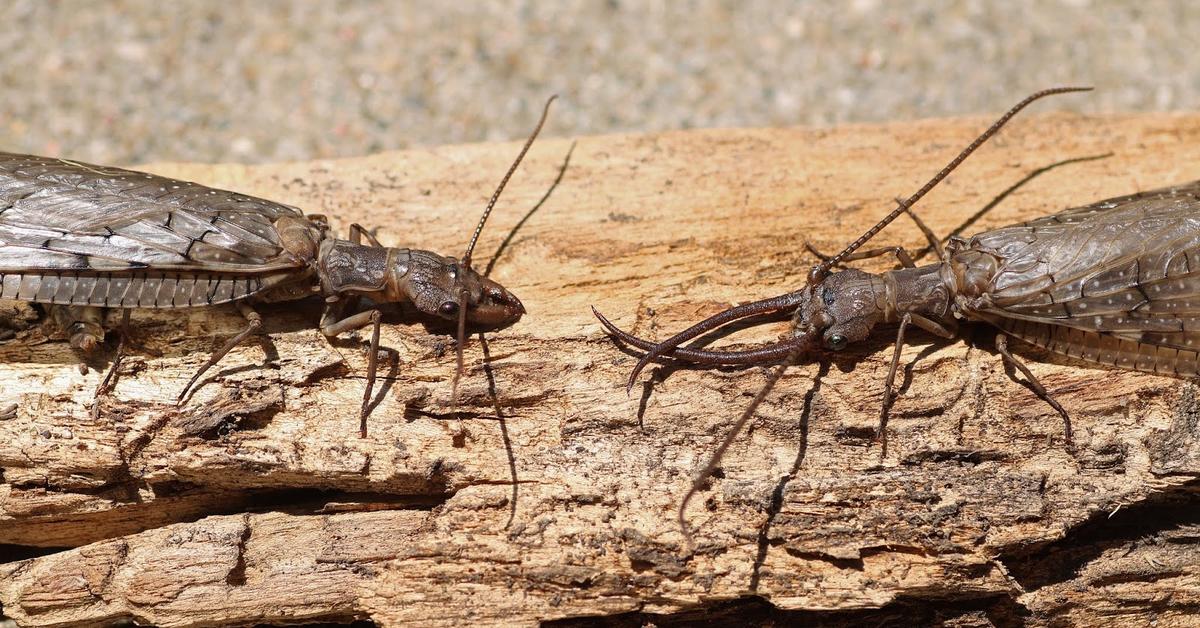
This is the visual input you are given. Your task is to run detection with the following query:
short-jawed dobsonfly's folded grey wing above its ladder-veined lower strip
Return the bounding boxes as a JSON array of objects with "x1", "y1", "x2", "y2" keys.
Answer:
[{"x1": 0, "y1": 152, "x2": 301, "y2": 273}]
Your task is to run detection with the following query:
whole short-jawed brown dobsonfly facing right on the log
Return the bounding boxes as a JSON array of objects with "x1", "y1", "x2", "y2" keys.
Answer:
[{"x1": 0, "y1": 96, "x2": 554, "y2": 436}]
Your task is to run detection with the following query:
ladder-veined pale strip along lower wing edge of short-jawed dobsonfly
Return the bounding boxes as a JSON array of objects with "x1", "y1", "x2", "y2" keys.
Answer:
[{"x1": 0, "y1": 271, "x2": 272, "y2": 307}]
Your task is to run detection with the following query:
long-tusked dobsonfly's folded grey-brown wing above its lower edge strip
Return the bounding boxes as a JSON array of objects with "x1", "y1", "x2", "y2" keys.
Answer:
[{"x1": 966, "y1": 181, "x2": 1200, "y2": 348}]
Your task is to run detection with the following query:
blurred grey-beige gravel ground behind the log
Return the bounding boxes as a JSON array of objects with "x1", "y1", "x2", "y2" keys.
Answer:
[{"x1": 0, "y1": 0, "x2": 1200, "y2": 163}]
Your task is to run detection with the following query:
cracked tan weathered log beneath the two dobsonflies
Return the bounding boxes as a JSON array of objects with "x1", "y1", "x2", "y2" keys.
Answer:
[{"x1": 0, "y1": 114, "x2": 1200, "y2": 626}]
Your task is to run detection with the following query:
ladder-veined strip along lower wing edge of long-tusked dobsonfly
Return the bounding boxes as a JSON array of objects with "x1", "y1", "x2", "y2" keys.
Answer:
[{"x1": 986, "y1": 316, "x2": 1200, "y2": 377}]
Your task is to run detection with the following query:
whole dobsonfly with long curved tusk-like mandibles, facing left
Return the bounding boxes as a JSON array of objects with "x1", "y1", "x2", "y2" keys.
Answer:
[{"x1": 593, "y1": 88, "x2": 1200, "y2": 532}]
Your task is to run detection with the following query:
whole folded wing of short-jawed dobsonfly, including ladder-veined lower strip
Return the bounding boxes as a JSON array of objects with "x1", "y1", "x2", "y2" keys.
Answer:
[{"x1": 0, "y1": 152, "x2": 314, "y2": 307}]
